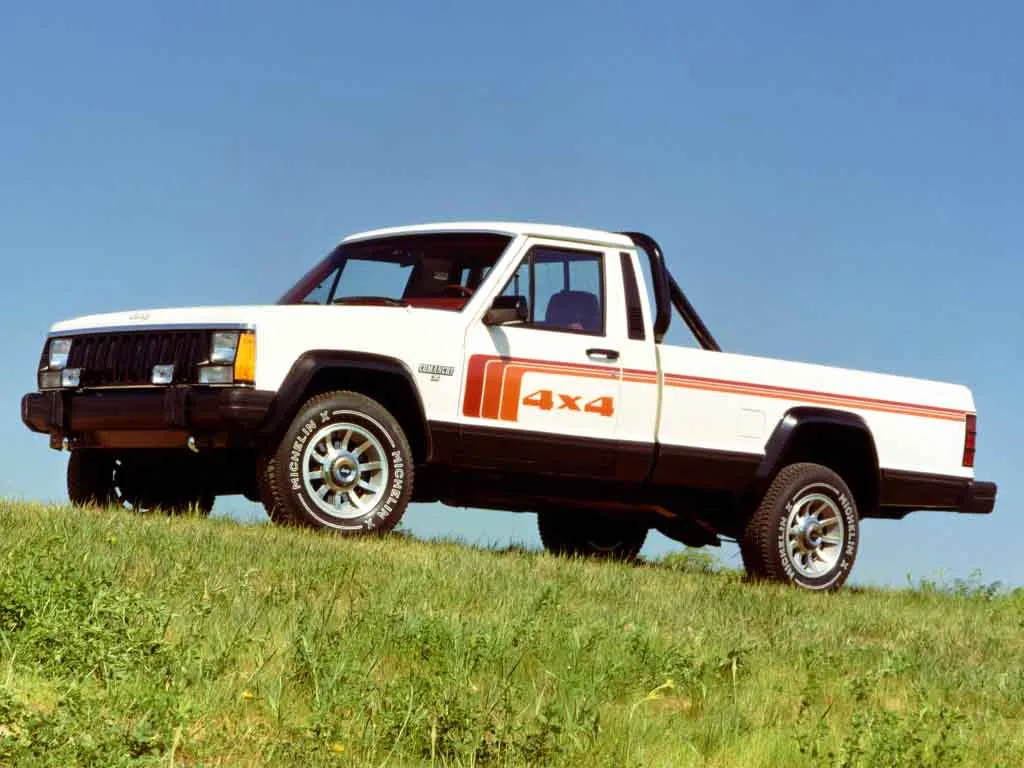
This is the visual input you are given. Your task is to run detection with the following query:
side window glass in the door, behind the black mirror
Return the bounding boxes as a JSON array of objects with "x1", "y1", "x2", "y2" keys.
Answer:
[{"x1": 502, "y1": 246, "x2": 604, "y2": 336}]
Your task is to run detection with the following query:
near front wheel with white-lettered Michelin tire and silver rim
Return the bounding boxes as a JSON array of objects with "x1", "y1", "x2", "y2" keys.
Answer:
[{"x1": 262, "y1": 391, "x2": 414, "y2": 535}]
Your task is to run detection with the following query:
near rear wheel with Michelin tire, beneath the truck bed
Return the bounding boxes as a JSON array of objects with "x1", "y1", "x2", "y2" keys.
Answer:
[{"x1": 740, "y1": 463, "x2": 860, "y2": 590}]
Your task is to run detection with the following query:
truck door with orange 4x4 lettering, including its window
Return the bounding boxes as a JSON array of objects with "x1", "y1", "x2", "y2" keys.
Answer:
[{"x1": 460, "y1": 241, "x2": 622, "y2": 478}]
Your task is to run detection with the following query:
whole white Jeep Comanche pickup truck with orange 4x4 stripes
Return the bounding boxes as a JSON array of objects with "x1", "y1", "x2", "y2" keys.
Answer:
[{"x1": 22, "y1": 222, "x2": 996, "y2": 589}]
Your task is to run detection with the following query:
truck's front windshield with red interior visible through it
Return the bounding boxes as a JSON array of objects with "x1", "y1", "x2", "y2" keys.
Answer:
[{"x1": 278, "y1": 232, "x2": 511, "y2": 311}]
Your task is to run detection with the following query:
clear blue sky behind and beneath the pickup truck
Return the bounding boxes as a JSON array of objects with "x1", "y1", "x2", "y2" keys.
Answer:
[{"x1": 0, "y1": 1, "x2": 1024, "y2": 585}]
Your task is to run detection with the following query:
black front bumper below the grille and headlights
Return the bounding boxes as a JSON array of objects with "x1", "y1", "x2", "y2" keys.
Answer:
[{"x1": 22, "y1": 386, "x2": 274, "y2": 446}]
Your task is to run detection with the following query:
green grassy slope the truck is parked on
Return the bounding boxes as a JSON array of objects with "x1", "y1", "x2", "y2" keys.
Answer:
[{"x1": 0, "y1": 502, "x2": 1024, "y2": 767}]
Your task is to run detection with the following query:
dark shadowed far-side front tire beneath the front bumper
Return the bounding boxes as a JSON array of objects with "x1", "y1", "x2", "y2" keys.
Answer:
[{"x1": 68, "y1": 451, "x2": 214, "y2": 517}]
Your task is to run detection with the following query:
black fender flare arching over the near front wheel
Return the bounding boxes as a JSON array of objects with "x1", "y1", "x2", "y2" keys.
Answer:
[{"x1": 260, "y1": 349, "x2": 431, "y2": 457}]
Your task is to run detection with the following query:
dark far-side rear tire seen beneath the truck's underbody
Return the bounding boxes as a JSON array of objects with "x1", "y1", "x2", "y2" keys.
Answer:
[{"x1": 537, "y1": 511, "x2": 647, "y2": 562}]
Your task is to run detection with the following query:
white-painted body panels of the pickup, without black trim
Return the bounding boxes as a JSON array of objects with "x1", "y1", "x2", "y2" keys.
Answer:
[{"x1": 50, "y1": 222, "x2": 975, "y2": 478}]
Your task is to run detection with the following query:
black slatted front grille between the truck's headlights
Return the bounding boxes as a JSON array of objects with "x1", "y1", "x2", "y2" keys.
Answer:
[{"x1": 68, "y1": 331, "x2": 212, "y2": 387}]
